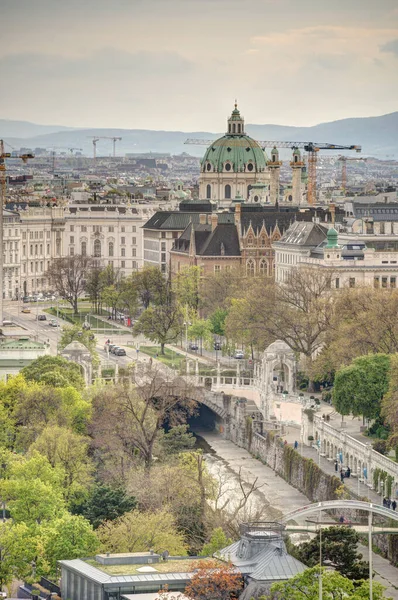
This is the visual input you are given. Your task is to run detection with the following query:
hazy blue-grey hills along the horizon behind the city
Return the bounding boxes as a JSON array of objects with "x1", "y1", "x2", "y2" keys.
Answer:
[{"x1": 0, "y1": 112, "x2": 398, "y2": 158}]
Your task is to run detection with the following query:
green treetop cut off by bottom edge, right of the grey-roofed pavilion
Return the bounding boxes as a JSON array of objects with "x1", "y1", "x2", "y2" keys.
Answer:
[{"x1": 271, "y1": 567, "x2": 385, "y2": 600}]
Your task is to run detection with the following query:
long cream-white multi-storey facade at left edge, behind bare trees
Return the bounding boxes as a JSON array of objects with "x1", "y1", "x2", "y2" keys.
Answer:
[{"x1": 3, "y1": 204, "x2": 157, "y2": 299}]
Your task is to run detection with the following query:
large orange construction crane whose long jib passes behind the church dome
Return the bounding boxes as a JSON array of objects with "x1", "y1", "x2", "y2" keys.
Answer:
[{"x1": 184, "y1": 138, "x2": 362, "y2": 204}]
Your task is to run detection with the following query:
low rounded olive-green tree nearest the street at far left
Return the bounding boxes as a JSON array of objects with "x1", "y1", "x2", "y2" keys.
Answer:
[{"x1": 21, "y1": 356, "x2": 84, "y2": 390}]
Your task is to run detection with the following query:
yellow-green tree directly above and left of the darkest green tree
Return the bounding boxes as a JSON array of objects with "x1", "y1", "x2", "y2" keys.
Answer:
[{"x1": 29, "y1": 426, "x2": 93, "y2": 501}]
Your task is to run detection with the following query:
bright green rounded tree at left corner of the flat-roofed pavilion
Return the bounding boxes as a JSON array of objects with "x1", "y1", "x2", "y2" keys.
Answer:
[{"x1": 42, "y1": 513, "x2": 99, "y2": 576}]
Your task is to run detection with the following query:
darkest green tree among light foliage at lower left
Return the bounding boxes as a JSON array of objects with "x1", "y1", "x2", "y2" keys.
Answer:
[{"x1": 71, "y1": 484, "x2": 137, "y2": 529}]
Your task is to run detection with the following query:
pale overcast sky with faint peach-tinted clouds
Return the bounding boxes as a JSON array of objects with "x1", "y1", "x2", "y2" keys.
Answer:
[{"x1": 0, "y1": 0, "x2": 398, "y2": 132}]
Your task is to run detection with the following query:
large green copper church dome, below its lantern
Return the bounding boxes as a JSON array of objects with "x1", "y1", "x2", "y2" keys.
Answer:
[{"x1": 201, "y1": 134, "x2": 266, "y2": 173}]
